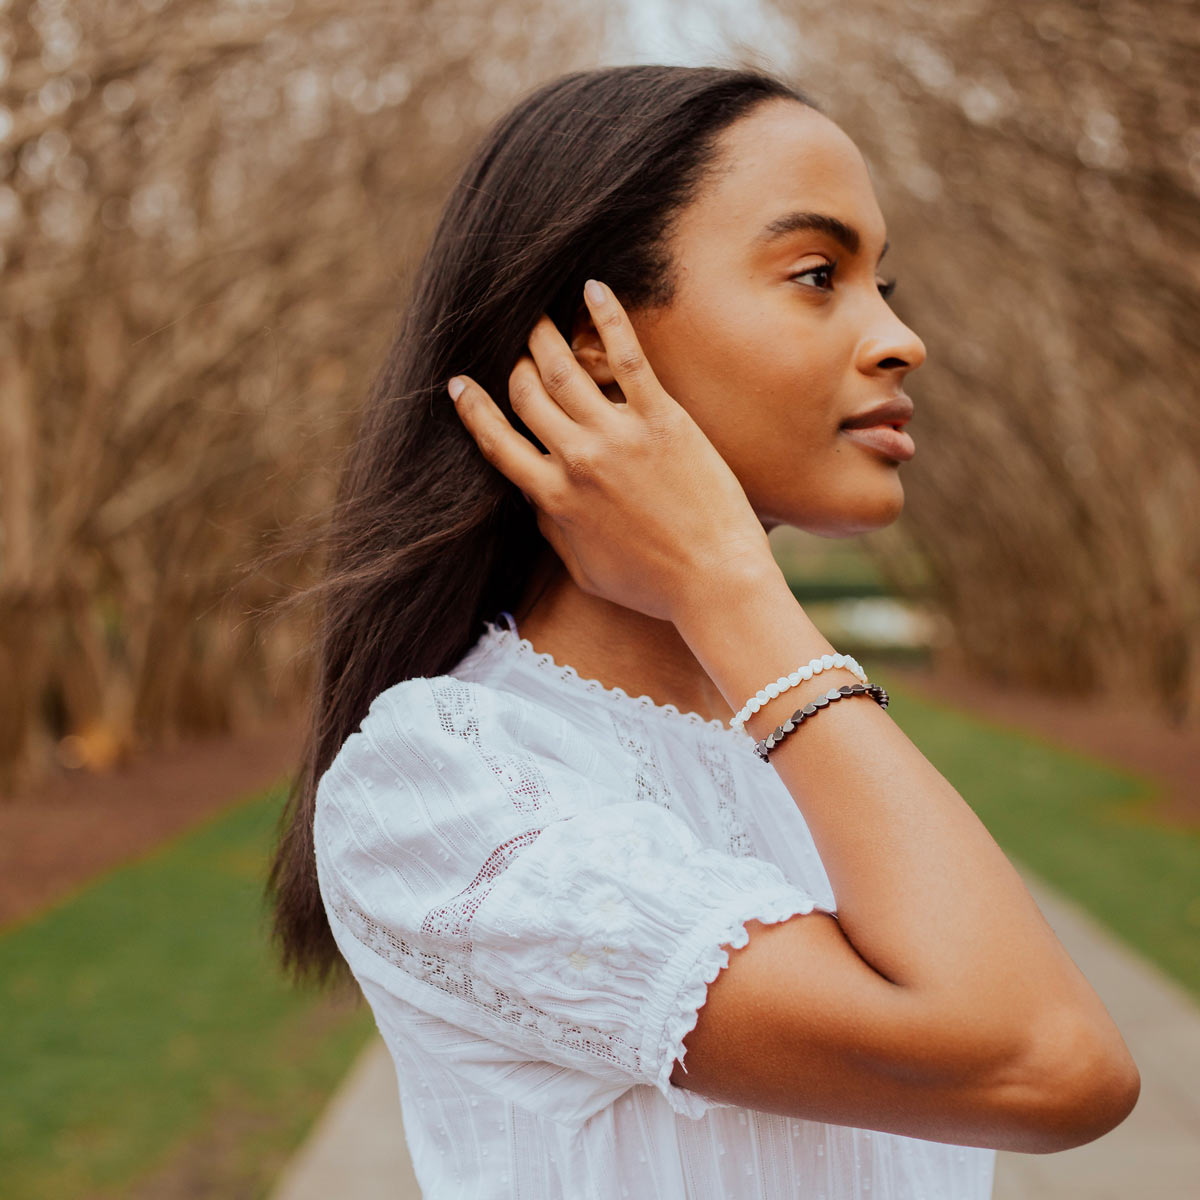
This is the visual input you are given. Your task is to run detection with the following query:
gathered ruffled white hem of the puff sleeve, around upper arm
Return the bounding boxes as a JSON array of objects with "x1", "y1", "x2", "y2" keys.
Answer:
[{"x1": 649, "y1": 886, "x2": 836, "y2": 1121}]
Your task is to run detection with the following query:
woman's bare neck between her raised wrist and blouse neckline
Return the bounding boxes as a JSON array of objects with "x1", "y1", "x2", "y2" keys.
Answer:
[{"x1": 512, "y1": 550, "x2": 733, "y2": 721}]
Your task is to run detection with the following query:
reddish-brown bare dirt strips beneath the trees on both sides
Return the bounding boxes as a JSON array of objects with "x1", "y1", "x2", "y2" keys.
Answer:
[{"x1": 0, "y1": 666, "x2": 1200, "y2": 928}]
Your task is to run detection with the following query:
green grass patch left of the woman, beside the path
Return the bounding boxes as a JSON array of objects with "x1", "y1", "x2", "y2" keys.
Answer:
[{"x1": 0, "y1": 792, "x2": 373, "y2": 1200}]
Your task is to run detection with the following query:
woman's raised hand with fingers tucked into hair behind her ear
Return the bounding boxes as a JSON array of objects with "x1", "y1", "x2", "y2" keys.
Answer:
[{"x1": 448, "y1": 281, "x2": 774, "y2": 620}]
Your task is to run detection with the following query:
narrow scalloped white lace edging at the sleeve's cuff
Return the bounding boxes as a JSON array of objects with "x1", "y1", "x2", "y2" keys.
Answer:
[{"x1": 655, "y1": 888, "x2": 836, "y2": 1118}]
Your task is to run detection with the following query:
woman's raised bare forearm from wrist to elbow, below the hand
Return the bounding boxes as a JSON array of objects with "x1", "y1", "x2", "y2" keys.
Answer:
[{"x1": 676, "y1": 561, "x2": 1115, "y2": 1070}]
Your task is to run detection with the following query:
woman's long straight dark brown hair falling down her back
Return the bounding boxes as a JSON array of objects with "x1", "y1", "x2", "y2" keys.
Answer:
[{"x1": 268, "y1": 66, "x2": 818, "y2": 983}]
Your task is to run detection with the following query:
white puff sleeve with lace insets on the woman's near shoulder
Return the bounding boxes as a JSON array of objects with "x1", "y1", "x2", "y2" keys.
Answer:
[{"x1": 314, "y1": 676, "x2": 834, "y2": 1122}]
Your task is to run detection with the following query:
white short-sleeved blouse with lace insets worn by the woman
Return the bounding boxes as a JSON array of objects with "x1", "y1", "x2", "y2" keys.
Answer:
[{"x1": 314, "y1": 613, "x2": 996, "y2": 1200}]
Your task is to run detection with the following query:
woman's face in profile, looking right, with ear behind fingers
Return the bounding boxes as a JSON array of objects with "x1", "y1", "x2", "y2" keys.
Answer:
[{"x1": 571, "y1": 100, "x2": 925, "y2": 538}]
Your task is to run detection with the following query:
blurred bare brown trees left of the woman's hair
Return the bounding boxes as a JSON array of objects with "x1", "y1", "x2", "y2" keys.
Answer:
[{"x1": 0, "y1": 0, "x2": 596, "y2": 790}]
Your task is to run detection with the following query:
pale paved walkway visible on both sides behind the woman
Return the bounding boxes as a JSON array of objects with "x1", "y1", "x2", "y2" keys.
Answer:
[{"x1": 272, "y1": 870, "x2": 1200, "y2": 1200}]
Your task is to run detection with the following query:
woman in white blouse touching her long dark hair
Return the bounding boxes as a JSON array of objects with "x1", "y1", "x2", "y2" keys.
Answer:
[{"x1": 272, "y1": 66, "x2": 1139, "y2": 1200}]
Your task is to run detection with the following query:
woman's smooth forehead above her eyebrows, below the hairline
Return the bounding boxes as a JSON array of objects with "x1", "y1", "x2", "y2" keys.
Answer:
[{"x1": 676, "y1": 100, "x2": 886, "y2": 253}]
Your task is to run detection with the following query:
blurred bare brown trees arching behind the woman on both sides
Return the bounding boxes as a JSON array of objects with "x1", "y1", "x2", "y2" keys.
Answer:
[{"x1": 0, "y1": 0, "x2": 1200, "y2": 791}]
